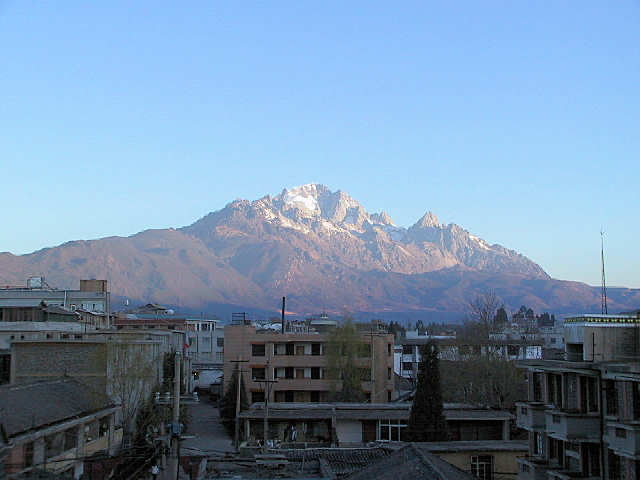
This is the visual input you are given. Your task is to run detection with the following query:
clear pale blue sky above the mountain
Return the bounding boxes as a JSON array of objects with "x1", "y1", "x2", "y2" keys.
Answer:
[{"x1": 0, "y1": 0, "x2": 640, "y2": 287}]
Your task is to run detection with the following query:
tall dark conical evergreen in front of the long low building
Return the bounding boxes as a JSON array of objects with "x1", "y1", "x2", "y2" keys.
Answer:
[{"x1": 407, "y1": 342, "x2": 447, "y2": 442}]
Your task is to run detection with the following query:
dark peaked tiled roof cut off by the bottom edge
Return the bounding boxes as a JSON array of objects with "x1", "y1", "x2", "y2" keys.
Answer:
[{"x1": 346, "y1": 444, "x2": 475, "y2": 480}]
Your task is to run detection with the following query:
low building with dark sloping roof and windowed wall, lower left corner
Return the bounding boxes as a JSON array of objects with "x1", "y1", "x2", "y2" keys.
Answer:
[{"x1": 0, "y1": 378, "x2": 122, "y2": 478}]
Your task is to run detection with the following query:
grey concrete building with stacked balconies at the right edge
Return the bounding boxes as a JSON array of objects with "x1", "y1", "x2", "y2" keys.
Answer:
[{"x1": 517, "y1": 314, "x2": 640, "y2": 480}]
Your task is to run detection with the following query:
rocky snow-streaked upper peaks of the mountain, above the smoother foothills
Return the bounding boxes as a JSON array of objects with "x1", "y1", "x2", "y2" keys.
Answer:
[{"x1": 184, "y1": 183, "x2": 548, "y2": 278}]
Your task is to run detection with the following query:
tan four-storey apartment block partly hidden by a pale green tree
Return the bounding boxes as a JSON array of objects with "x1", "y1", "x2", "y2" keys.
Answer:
[{"x1": 224, "y1": 319, "x2": 394, "y2": 403}]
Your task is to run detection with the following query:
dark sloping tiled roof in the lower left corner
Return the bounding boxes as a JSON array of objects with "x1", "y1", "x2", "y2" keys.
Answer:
[{"x1": 0, "y1": 377, "x2": 113, "y2": 437}]
